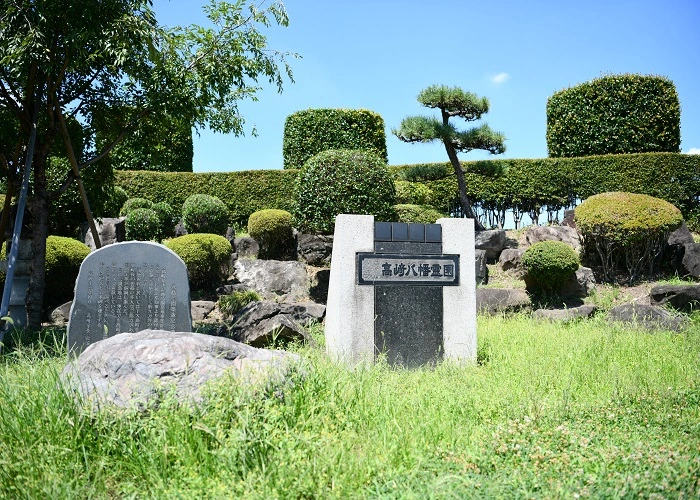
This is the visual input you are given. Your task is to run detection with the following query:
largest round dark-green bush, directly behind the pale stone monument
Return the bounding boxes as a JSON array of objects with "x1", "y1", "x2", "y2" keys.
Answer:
[{"x1": 295, "y1": 149, "x2": 396, "y2": 234}]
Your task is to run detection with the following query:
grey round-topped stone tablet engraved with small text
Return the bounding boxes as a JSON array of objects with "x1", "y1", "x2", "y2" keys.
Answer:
[{"x1": 68, "y1": 241, "x2": 192, "y2": 352}]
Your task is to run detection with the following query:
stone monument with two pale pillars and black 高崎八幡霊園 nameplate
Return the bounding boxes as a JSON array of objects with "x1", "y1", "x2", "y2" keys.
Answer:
[{"x1": 326, "y1": 215, "x2": 476, "y2": 367}]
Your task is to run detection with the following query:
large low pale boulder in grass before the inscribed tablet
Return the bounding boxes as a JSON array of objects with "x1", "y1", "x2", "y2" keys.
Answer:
[{"x1": 61, "y1": 330, "x2": 299, "y2": 407}]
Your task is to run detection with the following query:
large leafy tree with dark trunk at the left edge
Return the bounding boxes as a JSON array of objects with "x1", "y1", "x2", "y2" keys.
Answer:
[{"x1": 0, "y1": 0, "x2": 292, "y2": 327}]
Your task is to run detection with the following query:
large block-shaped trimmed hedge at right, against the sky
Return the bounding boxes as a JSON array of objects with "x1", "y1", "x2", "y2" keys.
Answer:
[{"x1": 547, "y1": 74, "x2": 681, "y2": 158}]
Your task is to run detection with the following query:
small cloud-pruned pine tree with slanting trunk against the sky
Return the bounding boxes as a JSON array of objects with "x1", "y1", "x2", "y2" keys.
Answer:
[{"x1": 392, "y1": 85, "x2": 505, "y2": 228}]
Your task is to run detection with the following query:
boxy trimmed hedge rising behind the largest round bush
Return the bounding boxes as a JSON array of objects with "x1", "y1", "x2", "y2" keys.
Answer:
[{"x1": 282, "y1": 109, "x2": 388, "y2": 169}]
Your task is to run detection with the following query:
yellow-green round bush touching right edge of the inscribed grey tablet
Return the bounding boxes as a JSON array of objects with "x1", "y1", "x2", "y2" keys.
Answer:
[{"x1": 165, "y1": 233, "x2": 233, "y2": 287}]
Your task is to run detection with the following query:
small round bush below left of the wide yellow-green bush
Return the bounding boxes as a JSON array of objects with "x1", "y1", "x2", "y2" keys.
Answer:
[{"x1": 521, "y1": 241, "x2": 579, "y2": 292}]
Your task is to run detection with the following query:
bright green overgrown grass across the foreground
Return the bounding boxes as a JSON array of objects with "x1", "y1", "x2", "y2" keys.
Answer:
[{"x1": 0, "y1": 316, "x2": 700, "y2": 498}]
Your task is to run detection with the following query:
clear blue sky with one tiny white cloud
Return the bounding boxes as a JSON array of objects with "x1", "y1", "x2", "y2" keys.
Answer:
[{"x1": 154, "y1": 0, "x2": 700, "y2": 172}]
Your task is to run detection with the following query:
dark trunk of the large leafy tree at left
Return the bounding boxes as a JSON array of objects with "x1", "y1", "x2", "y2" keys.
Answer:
[{"x1": 27, "y1": 154, "x2": 49, "y2": 330}]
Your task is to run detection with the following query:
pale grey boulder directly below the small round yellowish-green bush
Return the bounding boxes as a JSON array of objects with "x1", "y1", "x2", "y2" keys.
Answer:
[{"x1": 233, "y1": 259, "x2": 310, "y2": 302}]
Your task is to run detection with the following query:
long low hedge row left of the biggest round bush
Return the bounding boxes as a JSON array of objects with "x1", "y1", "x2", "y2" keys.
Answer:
[{"x1": 115, "y1": 170, "x2": 297, "y2": 227}]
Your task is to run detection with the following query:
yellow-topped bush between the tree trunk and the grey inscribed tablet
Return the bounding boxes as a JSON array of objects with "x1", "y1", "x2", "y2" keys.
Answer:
[{"x1": 44, "y1": 236, "x2": 90, "y2": 309}]
